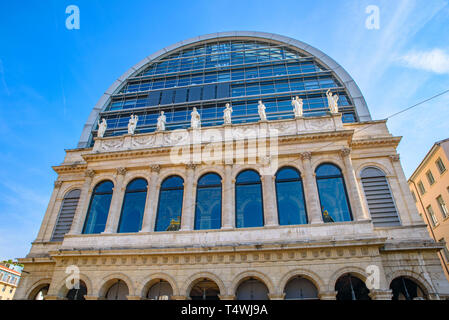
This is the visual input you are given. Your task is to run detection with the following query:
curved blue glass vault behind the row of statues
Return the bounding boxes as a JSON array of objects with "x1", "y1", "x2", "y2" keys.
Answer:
[{"x1": 79, "y1": 32, "x2": 369, "y2": 147}]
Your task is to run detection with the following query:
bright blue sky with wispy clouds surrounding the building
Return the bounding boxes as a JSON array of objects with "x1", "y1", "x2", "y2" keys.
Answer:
[{"x1": 0, "y1": 0, "x2": 449, "y2": 259}]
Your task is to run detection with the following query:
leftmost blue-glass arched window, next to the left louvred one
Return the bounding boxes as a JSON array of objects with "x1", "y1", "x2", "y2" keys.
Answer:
[{"x1": 83, "y1": 181, "x2": 114, "y2": 234}]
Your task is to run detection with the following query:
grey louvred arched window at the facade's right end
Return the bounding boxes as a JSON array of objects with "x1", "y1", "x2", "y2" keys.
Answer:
[{"x1": 360, "y1": 167, "x2": 401, "y2": 227}]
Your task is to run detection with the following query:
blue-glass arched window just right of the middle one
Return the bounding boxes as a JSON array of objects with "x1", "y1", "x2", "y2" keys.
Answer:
[{"x1": 235, "y1": 170, "x2": 264, "y2": 228}]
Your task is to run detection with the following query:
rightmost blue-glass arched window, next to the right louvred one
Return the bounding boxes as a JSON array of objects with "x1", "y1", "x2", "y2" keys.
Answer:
[{"x1": 315, "y1": 163, "x2": 352, "y2": 222}]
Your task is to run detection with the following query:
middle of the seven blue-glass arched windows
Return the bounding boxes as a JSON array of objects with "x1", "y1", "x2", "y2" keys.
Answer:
[{"x1": 195, "y1": 173, "x2": 221, "y2": 230}]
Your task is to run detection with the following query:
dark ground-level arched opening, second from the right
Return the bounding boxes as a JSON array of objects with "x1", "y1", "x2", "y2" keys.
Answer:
[{"x1": 335, "y1": 273, "x2": 371, "y2": 300}]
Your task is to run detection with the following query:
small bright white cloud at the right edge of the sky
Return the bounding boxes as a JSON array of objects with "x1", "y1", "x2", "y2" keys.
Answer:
[{"x1": 400, "y1": 49, "x2": 449, "y2": 74}]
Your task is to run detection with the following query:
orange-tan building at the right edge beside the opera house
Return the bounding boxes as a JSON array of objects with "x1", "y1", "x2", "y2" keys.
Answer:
[{"x1": 408, "y1": 139, "x2": 449, "y2": 280}]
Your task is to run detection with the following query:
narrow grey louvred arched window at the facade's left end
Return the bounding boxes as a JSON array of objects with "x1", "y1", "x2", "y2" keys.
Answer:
[{"x1": 51, "y1": 189, "x2": 81, "y2": 241}]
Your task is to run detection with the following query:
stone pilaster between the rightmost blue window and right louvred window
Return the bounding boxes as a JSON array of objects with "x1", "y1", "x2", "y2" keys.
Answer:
[{"x1": 340, "y1": 148, "x2": 368, "y2": 221}]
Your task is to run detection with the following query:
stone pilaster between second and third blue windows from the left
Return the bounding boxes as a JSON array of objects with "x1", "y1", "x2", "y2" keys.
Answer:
[{"x1": 141, "y1": 164, "x2": 161, "y2": 232}]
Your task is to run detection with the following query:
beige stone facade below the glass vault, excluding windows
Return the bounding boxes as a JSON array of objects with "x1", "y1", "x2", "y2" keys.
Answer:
[{"x1": 15, "y1": 114, "x2": 449, "y2": 299}]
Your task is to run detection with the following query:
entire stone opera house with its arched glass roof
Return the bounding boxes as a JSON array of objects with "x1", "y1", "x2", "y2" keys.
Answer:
[{"x1": 16, "y1": 32, "x2": 449, "y2": 299}]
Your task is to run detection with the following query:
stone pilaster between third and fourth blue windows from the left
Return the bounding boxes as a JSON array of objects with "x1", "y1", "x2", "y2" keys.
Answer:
[{"x1": 181, "y1": 163, "x2": 196, "y2": 231}]
